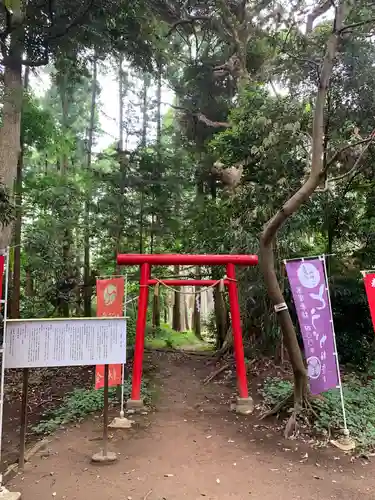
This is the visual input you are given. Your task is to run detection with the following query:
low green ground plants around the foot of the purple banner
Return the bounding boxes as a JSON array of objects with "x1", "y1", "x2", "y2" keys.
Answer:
[{"x1": 262, "y1": 375, "x2": 375, "y2": 449}]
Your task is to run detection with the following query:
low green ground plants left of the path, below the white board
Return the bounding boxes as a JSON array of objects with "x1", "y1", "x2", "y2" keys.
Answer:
[{"x1": 32, "y1": 380, "x2": 150, "y2": 434}]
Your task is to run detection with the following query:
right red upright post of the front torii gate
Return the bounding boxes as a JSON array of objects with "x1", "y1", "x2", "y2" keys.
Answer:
[{"x1": 227, "y1": 264, "x2": 249, "y2": 399}]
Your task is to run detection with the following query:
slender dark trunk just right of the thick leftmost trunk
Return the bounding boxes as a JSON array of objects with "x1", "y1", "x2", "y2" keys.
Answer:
[{"x1": 10, "y1": 67, "x2": 30, "y2": 318}]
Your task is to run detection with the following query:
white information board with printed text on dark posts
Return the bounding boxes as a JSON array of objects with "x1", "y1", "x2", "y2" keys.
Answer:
[{"x1": 4, "y1": 317, "x2": 126, "y2": 368}]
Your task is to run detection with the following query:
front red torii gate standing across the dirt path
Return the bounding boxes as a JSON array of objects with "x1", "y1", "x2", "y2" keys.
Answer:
[{"x1": 117, "y1": 254, "x2": 258, "y2": 414}]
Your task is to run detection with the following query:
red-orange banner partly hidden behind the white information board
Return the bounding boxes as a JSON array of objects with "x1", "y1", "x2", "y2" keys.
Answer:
[{"x1": 95, "y1": 278, "x2": 125, "y2": 389}]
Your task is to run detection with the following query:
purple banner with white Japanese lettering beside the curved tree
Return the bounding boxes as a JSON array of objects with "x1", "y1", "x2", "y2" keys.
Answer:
[{"x1": 286, "y1": 257, "x2": 339, "y2": 394}]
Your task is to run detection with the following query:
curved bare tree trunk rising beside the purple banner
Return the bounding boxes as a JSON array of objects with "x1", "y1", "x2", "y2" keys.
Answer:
[{"x1": 260, "y1": 4, "x2": 345, "y2": 412}]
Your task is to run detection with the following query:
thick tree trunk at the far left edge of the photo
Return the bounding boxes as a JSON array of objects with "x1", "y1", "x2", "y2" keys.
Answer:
[{"x1": 0, "y1": 19, "x2": 23, "y2": 249}]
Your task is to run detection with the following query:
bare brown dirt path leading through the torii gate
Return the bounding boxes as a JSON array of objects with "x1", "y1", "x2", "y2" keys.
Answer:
[{"x1": 8, "y1": 354, "x2": 375, "y2": 500}]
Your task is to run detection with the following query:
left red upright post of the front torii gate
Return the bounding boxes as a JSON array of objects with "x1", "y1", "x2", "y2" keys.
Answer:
[{"x1": 127, "y1": 263, "x2": 150, "y2": 409}]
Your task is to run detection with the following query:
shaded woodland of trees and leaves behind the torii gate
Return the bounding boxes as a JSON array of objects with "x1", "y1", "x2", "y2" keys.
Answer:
[{"x1": 0, "y1": 0, "x2": 375, "y2": 444}]
